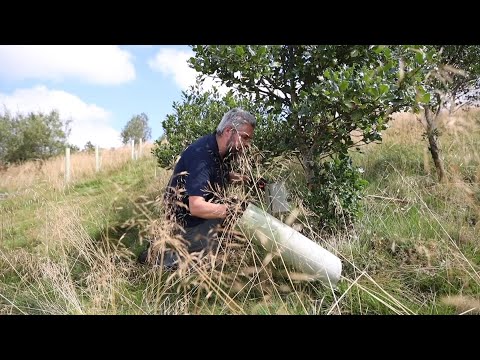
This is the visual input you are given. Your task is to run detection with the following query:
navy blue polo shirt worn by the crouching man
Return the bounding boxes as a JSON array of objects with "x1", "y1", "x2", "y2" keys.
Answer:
[{"x1": 166, "y1": 133, "x2": 230, "y2": 227}]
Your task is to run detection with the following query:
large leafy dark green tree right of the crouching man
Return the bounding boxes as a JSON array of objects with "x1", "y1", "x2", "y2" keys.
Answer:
[{"x1": 190, "y1": 45, "x2": 430, "y2": 222}]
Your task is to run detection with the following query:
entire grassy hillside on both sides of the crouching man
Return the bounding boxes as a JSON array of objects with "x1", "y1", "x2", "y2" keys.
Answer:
[{"x1": 0, "y1": 111, "x2": 480, "y2": 314}]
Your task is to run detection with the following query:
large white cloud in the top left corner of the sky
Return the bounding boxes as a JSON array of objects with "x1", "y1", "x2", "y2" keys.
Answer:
[{"x1": 0, "y1": 45, "x2": 135, "y2": 85}]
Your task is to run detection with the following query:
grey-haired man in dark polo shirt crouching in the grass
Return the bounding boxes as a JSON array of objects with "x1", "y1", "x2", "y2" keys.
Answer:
[{"x1": 139, "y1": 108, "x2": 256, "y2": 268}]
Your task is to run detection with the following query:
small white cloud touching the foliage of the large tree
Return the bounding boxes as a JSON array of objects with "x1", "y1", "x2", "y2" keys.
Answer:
[{"x1": 148, "y1": 47, "x2": 229, "y2": 94}]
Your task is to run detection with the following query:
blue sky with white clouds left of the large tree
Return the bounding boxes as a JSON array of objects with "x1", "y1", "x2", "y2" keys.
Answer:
[{"x1": 0, "y1": 45, "x2": 224, "y2": 149}]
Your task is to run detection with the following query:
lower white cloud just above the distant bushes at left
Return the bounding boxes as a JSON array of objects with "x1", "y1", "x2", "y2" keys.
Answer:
[{"x1": 0, "y1": 86, "x2": 121, "y2": 149}]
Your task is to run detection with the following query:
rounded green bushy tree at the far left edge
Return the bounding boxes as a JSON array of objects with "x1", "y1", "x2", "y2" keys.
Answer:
[{"x1": 0, "y1": 110, "x2": 70, "y2": 163}]
